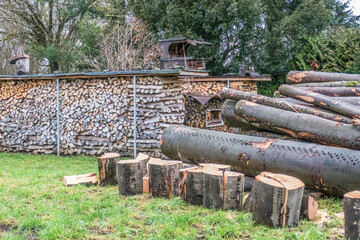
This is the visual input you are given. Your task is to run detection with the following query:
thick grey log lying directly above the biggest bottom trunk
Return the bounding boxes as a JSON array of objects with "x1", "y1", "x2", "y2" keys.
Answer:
[{"x1": 235, "y1": 100, "x2": 360, "y2": 150}]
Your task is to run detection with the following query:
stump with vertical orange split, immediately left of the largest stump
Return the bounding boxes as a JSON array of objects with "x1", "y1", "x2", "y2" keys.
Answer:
[{"x1": 203, "y1": 170, "x2": 245, "y2": 210}]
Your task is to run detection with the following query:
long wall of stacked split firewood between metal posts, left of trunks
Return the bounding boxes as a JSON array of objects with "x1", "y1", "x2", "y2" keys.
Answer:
[{"x1": 0, "y1": 76, "x2": 185, "y2": 156}]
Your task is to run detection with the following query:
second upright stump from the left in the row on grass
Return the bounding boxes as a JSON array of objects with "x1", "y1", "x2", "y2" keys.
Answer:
[{"x1": 116, "y1": 159, "x2": 147, "y2": 196}]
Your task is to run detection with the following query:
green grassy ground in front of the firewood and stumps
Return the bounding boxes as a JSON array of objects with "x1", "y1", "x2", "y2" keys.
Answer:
[{"x1": 0, "y1": 153, "x2": 344, "y2": 240}]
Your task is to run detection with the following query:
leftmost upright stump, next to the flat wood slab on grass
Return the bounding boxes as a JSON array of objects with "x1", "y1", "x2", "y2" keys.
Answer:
[{"x1": 98, "y1": 153, "x2": 120, "y2": 186}]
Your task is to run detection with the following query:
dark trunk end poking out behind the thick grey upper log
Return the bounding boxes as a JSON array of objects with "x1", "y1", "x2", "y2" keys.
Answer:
[{"x1": 221, "y1": 99, "x2": 259, "y2": 130}]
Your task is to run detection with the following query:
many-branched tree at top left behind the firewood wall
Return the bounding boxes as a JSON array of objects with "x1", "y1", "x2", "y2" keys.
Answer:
[{"x1": 0, "y1": 0, "x2": 100, "y2": 72}]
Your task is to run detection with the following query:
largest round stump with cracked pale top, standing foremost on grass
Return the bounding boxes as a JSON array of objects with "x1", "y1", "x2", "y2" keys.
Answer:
[{"x1": 253, "y1": 172, "x2": 305, "y2": 227}]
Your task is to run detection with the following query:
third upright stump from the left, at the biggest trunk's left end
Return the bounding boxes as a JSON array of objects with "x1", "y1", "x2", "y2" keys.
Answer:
[{"x1": 148, "y1": 158, "x2": 182, "y2": 199}]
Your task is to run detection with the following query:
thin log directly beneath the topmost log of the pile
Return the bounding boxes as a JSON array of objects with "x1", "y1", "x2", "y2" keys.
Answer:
[{"x1": 300, "y1": 87, "x2": 360, "y2": 97}]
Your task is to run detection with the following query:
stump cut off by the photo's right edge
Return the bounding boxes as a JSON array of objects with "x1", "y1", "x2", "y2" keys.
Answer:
[{"x1": 343, "y1": 191, "x2": 360, "y2": 240}]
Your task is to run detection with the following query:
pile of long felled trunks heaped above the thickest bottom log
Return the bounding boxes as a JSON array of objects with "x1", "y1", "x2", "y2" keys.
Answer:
[{"x1": 221, "y1": 72, "x2": 360, "y2": 151}]
